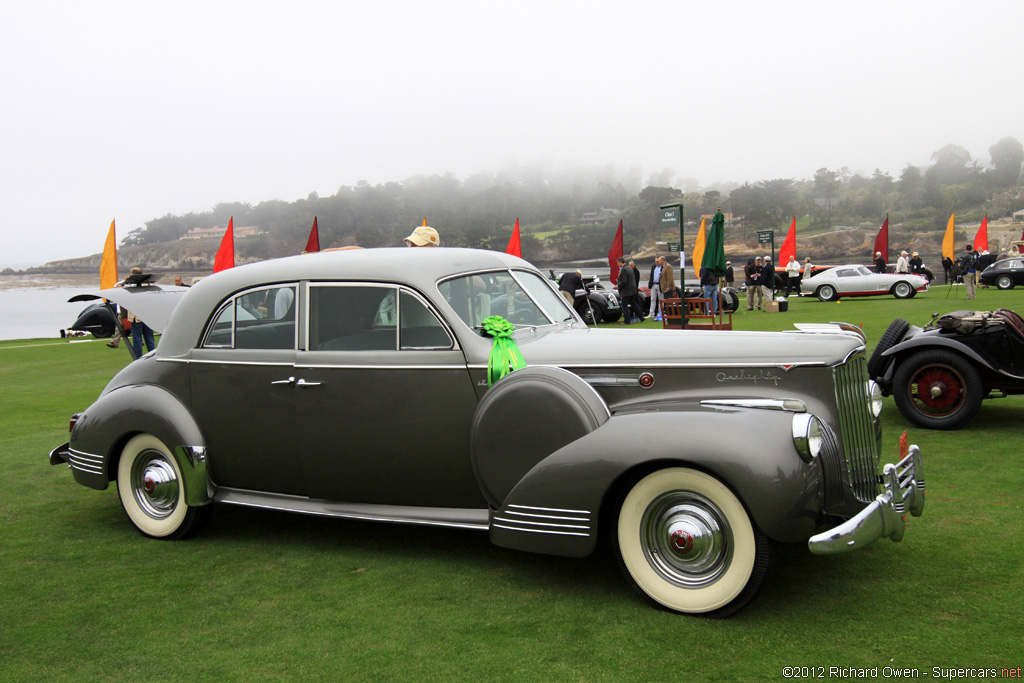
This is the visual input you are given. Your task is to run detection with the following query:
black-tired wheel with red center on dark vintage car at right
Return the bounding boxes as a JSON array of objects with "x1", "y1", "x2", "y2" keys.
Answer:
[{"x1": 893, "y1": 349, "x2": 985, "y2": 429}]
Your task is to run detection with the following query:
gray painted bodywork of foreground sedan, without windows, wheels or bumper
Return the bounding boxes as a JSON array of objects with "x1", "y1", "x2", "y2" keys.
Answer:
[{"x1": 59, "y1": 249, "x2": 878, "y2": 556}]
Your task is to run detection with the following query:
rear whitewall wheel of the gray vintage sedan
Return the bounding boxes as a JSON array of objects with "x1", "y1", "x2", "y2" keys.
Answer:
[{"x1": 118, "y1": 434, "x2": 211, "y2": 540}]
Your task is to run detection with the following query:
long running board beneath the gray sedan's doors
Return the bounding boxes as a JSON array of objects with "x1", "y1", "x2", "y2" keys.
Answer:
[{"x1": 213, "y1": 487, "x2": 489, "y2": 531}]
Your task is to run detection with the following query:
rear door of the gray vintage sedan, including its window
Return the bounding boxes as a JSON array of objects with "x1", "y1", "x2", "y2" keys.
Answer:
[{"x1": 189, "y1": 284, "x2": 305, "y2": 495}]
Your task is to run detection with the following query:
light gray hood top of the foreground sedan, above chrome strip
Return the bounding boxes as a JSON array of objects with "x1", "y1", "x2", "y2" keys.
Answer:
[{"x1": 516, "y1": 328, "x2": 864, "y2": 368}]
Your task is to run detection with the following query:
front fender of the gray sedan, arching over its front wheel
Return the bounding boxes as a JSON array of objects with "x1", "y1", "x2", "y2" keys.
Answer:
[{"x1": 490, "y1": 409, "x2": 823, "y2": 557}]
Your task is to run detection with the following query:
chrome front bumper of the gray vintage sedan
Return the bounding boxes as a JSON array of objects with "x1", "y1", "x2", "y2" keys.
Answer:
[{"x1": 807, "y1": 445, "x2": 925, "y2": 555}]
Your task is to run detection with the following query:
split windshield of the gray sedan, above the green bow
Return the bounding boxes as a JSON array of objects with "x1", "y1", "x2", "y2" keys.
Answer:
[{"x1": 438, "y1": 270, "x2": 575, "y2": 328}]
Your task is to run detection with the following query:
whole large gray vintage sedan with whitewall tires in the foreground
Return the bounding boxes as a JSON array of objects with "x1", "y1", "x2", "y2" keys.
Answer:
[{"x1": 49, "y1": 249, "x2": 925, "y2": 616}]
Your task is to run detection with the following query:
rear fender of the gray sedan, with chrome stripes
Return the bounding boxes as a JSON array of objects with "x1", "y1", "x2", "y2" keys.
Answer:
[{"x1": 70, "y1": 384, "x2": 211, "y2": 505}]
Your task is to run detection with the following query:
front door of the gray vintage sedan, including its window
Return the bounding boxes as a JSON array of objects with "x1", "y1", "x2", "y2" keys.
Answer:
[{"x1": 293, "y1": 283, "x2": 486, "y2": 508}]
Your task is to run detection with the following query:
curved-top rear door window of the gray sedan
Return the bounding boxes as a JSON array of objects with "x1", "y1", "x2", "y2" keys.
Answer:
[{"x1": 203, "y1": 287, "x2": 295, "y2": 349}]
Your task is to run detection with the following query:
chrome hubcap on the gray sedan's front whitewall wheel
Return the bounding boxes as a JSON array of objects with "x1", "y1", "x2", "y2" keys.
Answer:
[{"x1": 640, "y1": 492, "x2": 732, "y2": 588}]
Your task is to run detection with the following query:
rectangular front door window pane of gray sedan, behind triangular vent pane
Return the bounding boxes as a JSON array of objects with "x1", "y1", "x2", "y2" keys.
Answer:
[{"x1": 309, "y1": 285, "x2": 398, "y2": 351}]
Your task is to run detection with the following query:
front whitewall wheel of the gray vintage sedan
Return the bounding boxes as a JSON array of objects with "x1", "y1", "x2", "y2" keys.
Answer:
[{"x1": 613, "y1": 467, "x2": 773, "y2": 618}]
